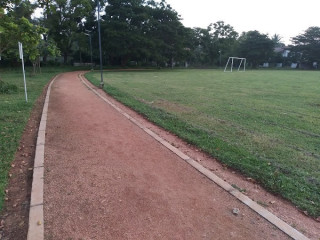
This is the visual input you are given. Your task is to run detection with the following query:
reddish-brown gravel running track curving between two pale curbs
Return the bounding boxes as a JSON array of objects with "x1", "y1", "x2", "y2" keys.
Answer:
[{"x1": 44, "y1": 72, "x2": 288, "y2": 240}]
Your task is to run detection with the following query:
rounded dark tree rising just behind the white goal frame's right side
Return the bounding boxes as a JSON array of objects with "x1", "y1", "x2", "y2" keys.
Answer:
[{"x1": 237, "y1": 31, "x2": 275, "y2": 68}]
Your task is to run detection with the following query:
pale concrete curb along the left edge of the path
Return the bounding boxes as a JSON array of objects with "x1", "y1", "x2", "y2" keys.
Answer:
[{"x1": 27, "y1": 74, "x2": 60, "y2": 240}]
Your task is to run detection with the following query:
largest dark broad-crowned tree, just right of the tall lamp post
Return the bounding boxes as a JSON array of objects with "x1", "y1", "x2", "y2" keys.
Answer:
[{"x1": 102, "y1": 0, "x2": 187, "y2": 65}]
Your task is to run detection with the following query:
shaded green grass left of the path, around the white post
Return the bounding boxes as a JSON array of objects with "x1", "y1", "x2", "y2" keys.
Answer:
[{"x1": 0, "y1": 68, "x2": 65, "y2": 210}]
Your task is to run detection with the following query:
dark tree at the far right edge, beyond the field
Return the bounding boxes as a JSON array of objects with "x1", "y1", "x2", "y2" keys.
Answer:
[{"x1": 291, "y1": 27, "x2": 320, "y2": 65}]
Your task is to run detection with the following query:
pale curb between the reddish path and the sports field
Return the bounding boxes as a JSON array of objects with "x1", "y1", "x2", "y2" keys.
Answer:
[{"x1": 79, "y1": 74, "x2": 309, "y2": 240}]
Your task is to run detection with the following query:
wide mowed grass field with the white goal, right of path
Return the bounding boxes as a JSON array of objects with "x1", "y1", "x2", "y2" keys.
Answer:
[{"x1": 87, "y1": 70, "x2": 320, "y2": 217}]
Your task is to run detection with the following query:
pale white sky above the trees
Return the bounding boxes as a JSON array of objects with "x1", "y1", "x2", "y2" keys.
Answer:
[{"x1": 166, "y1": 0, "x2": 320, "y2": 44}]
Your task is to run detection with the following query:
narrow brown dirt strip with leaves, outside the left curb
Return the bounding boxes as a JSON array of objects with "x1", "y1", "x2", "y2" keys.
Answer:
[{"x1": 0, "y1": 85, "x2": 48, "y2": 240}]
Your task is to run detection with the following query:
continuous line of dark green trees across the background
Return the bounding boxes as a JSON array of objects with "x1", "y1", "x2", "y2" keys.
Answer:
[{"x1": 0, "y1": 0, "x2": 320, "y2": 71}]
